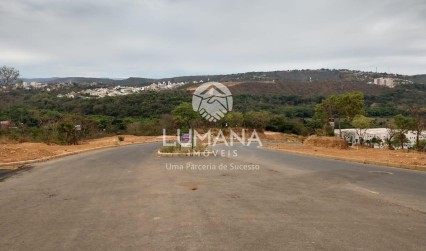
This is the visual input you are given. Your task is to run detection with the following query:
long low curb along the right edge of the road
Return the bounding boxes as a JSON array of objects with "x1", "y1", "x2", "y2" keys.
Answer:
[{"x1": 260, "y1": 147, "x2": 426, "y2": 172}]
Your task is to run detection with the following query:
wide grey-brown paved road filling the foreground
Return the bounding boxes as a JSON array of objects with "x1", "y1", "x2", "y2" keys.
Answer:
[{"x1": 0, "y1": 144, "x2": 426, "y2": 250}]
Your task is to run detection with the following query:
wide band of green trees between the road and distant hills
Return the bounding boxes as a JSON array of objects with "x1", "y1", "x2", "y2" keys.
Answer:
[{"x1": 0, "y1": 67, "x2": 426, "y2": 148}]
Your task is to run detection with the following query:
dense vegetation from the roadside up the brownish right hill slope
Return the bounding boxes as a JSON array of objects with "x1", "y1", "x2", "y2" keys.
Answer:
[{"x1": 0, "y1": 66, "x2": 426, "y2": 149}]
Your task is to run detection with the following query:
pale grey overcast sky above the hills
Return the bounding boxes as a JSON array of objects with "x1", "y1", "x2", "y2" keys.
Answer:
[{"x1": 0, "y1": 0, "x2": 426, "y2": 78}]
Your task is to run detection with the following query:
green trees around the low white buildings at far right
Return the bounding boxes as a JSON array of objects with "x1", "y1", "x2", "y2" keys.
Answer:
[{"x1": 314, "y1": 92, "x2": 426, "y2": 150}]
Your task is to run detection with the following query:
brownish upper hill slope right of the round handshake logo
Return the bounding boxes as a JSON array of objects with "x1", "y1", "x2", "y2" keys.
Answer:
[{"x1": 182, "y1": 69, "x2": 426, "y2": 97}]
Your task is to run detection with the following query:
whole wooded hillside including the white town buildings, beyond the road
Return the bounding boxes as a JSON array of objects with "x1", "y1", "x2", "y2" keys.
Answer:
[{"x1": 0, "y1": 70, "x2": 426, "y2": 144}]
